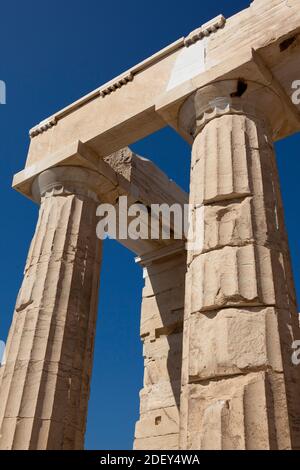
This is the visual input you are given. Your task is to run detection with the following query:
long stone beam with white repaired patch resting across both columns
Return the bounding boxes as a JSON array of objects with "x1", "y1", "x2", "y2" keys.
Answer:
[{"x1": 27, "y1": 0, "x2": 300, "y2": 166}]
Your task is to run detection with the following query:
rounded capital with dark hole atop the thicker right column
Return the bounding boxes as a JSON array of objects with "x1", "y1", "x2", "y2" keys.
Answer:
[{"x1": 178, "y1": 79, "x2": 284, "y2": 138}]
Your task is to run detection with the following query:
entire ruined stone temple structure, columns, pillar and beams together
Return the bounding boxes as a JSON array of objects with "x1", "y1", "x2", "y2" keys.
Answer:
[{"x1": 0, "y1": 0, "x2": 300, "y2": 450}]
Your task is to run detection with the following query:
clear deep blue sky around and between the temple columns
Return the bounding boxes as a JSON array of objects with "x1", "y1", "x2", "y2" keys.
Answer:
[{"x1": 0, "y1": 0, "x2": 300, "y2": 449}]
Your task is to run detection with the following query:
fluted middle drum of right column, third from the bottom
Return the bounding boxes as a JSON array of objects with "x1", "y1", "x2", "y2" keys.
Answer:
[{"x1": 187, "y1": 245, "x2": 275, "y2": 312}]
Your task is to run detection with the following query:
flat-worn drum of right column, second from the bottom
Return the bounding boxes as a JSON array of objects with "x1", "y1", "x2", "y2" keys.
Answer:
[{"x1": 189, "y1": 307, "x2": 284, "y2": 382}]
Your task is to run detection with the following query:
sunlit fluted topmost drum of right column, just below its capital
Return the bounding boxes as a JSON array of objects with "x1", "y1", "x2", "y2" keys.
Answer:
[{"x1": 190, "y1": 115, "x2": 255, "y2": 204}]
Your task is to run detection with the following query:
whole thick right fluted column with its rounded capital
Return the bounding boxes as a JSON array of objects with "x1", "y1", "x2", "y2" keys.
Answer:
[{"x1": 179, "y1": 80, "x2": 300, "y2": 450}]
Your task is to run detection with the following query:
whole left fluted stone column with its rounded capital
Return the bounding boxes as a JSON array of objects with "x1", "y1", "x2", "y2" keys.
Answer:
[{"x1": 0, "y1": 167, "x2": 101, "y2": 450}]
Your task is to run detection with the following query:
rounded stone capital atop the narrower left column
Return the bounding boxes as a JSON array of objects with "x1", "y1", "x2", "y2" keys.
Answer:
[{"x1": 32, "y1": 166, "x2": 108, "y2": 202}]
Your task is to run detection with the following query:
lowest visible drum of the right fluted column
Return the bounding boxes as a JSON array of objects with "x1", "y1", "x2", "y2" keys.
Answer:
[{"x1": 183, "y1": 372, "x2": 291, "y2": 450}]
